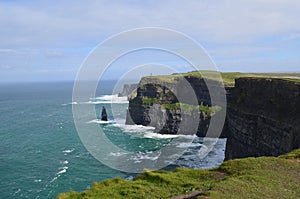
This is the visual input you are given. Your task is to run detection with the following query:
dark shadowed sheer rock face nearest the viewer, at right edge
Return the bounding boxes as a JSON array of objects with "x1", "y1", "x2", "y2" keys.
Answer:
[{"x1": 225, "y1": 78, "x2": 300, "y2": 159}]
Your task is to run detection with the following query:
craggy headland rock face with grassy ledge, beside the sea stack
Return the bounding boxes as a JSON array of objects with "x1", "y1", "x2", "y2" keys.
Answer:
[{"x1": 126, "y1": 76, "x2": 225, "y2": 137}]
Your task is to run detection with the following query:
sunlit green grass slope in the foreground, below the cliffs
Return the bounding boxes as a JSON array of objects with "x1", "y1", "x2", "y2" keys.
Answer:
[{"x1": 58, "y1": 149, "x2": 300, "y2": 199}]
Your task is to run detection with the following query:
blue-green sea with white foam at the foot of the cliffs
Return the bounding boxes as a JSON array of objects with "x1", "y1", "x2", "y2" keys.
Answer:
[{"x1": 0, "y1": 81, "x2": 226, "y2": 199}]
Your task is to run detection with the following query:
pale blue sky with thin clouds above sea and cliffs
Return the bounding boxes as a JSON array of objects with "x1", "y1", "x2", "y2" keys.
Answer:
[{"x1": 0, "y1": 0, "x2": 300, "y2": 82}]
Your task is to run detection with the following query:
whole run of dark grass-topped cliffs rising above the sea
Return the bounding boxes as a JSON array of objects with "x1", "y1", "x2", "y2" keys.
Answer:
[{"x1": 126, "y1": 73, "x2": 300, "y2": 160}]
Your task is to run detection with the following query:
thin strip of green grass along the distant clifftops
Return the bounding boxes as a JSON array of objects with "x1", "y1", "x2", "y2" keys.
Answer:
[{"x1": 141, "y1": 70, "x2": 300, "y2": 86}]
